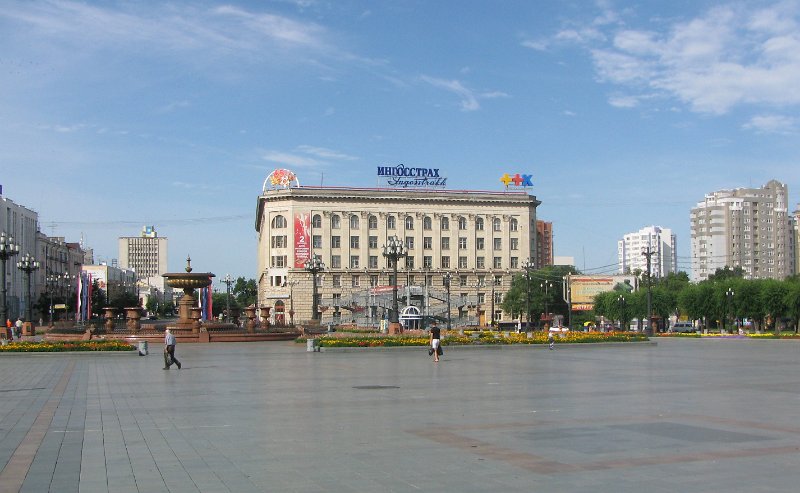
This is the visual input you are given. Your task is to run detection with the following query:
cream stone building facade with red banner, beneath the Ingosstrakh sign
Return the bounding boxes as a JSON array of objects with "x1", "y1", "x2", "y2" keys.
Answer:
[{"x1": 255, "y1": 181, "x2": 540, "y2": 326}]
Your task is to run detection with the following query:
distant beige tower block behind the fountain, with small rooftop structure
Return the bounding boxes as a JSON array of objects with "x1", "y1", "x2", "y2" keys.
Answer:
[{"x1": 119, "y1": 226, "x2": 168, "y2": 281}]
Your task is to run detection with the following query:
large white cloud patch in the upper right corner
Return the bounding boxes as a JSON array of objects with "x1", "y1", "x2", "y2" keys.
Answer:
[{"x1": 540, "y1": 0, "x2": 800, "y2": 115}]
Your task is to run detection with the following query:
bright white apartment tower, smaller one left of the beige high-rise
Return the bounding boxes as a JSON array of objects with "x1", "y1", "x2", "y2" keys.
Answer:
[{"x1": 617, "y1": 226, "x2": 678, "y2": 277}]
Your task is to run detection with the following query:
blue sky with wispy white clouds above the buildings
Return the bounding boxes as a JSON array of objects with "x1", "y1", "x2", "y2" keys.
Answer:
[{"x1": 0, "y1": 0, "x2": 800, "y2": 278}]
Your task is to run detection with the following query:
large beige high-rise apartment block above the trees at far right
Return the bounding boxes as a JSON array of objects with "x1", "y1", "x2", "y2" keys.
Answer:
[{"x1": 691, "y1": 180, "x2": 795, "y2": 281}]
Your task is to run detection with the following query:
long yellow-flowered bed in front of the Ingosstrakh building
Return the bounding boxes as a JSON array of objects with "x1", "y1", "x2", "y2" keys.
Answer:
[{"x1": 296, "y1": 331, "x2": 648, "y2": 347}]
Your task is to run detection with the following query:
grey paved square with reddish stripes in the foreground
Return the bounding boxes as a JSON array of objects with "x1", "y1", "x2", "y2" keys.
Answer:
[{"x1": 0, "y1": 339, "x2": 800, "y2": 493}]
